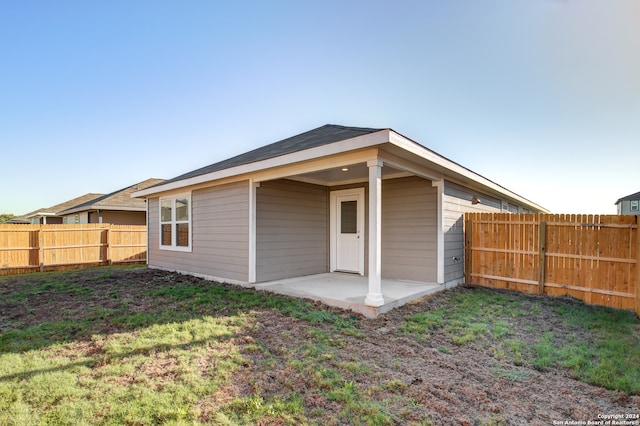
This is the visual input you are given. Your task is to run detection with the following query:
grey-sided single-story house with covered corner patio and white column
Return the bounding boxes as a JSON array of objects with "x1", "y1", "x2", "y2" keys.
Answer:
[{"x1": 133, "y1": 124, "x2": 547, "y2": 317}]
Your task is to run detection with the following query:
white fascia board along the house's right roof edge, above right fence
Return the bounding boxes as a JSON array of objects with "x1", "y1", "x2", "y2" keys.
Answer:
[{"x1": 389, "y1": 132, "x2": 548, "y2": 212}]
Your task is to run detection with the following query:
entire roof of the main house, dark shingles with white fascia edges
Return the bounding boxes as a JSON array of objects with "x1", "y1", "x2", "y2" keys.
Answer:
[{"x1": 133, "y1": 124, "x2": 547, "y2": 212}]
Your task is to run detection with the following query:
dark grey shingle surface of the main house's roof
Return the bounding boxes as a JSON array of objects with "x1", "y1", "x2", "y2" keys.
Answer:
[{"x1": 162, "y1": 124, "x2": 384, "y2": 185}]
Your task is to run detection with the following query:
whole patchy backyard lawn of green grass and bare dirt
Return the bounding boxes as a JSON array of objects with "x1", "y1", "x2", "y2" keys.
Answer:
[{"x1": 0, "y1": 267, "x2": 640, "y2": 425}]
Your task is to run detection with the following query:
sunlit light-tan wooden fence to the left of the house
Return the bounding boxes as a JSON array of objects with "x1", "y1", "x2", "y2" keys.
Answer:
[{"x1": 0, "y1": 224, "x2": 147, "y2": 275}]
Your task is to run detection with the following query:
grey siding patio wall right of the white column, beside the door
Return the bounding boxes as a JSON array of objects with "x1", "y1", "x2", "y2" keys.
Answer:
[{"x1": 382, "y1": 177, "x2": 438, "y2": 282}]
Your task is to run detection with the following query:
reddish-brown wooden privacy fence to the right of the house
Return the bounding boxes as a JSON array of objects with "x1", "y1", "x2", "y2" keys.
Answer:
[{"x1": 465, "y1": 213, "x2": 640, "y2": 316}]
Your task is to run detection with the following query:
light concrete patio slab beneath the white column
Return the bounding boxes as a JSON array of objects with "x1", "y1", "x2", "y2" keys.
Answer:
[{"x1": 254, "y1": 272, "x2": 448, "y2": 318}]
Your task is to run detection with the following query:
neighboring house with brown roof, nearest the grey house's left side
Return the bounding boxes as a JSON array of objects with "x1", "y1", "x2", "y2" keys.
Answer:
[{"x1": 58, "y1": 179, "x2": 164, "y2": 225}]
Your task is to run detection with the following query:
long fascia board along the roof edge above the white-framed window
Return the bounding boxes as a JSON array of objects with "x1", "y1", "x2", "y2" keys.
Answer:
[{"x1": 131, "y1": 129, "x2": 391, "y2": 198}]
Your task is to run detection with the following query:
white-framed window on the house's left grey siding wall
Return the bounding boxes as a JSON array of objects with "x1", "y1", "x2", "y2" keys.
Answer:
[{"x1": 160, "y1": 195, "x2": 191, "y2": 251}]
